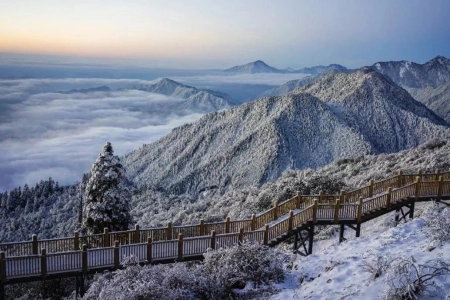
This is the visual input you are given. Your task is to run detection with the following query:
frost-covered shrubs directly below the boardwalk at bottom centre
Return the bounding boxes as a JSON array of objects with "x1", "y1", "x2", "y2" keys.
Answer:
[{"x1": 83, "y1": 243, "x2": 285, "y2": 300}]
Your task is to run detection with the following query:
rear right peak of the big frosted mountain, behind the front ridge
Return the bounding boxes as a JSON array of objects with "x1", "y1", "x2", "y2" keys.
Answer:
[{"x1": 297, "y1": 68, "x2": 448, "y2": 153}]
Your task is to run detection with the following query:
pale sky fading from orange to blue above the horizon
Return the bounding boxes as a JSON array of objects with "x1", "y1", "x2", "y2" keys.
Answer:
[{"x1": 0, "y1": 0, "x2": 450, "y2": 69}]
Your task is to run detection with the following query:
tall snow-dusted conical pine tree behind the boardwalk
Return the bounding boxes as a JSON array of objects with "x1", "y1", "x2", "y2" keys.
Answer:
[{"x1": 82, "y1": 142, "x2": 132, "y2": 234}]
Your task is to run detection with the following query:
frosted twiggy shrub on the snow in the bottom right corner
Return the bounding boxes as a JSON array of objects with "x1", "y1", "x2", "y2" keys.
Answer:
[{"x1": 382, "y1": 257, "x2": 450, "y2": 300}]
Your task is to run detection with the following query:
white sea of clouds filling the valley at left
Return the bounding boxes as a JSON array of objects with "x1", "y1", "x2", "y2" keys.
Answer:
[{"x1": 0, "y1": 79, "x2": 201, "y2": 191}]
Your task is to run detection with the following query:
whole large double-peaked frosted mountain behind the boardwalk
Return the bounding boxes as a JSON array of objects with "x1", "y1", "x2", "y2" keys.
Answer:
[{"x1": 123, "y1": 69, "x2": 449, "y2": 195}]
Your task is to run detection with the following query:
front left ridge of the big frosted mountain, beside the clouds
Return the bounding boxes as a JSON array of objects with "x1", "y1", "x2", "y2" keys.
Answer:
[{"x1": 124, "y1": 94, "x2": 371, "y2": 194}]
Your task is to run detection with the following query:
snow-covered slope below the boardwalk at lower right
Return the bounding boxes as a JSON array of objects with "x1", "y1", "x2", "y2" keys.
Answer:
[{"x1": 271, "y1": 200, "x2": 450, "y2": 300}]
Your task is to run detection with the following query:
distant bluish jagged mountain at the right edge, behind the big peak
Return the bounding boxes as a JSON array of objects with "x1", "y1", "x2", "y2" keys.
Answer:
[{"x1": 372, "y1": 56, "x2": 450, "y2": 88}]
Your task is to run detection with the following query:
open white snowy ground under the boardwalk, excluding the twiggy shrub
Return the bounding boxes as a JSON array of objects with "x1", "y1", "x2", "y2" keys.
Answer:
[{"x1": 272, "y1": 204, "x2": 450, "y2": 299}]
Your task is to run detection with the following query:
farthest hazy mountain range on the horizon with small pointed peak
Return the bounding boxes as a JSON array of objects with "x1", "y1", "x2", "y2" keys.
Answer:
[{"x1": 224, "y1": 60, "x2": 347, "y2": 74}]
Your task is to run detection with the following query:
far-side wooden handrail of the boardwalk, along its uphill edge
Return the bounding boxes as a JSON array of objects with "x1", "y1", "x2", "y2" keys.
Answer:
[{"x1": 0, "y1": 170, "x2": 450, "y2": 255}]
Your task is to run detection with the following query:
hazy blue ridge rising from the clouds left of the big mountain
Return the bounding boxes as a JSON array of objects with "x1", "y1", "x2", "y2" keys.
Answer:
[{"x1": 129, "y1": 78, "x2": 234, "y2": 113}]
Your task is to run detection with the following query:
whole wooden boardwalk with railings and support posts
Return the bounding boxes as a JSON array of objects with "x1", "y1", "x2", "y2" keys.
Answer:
[{"x1": 0, "y1": 171, "x2": 450, "y2": 286}]
